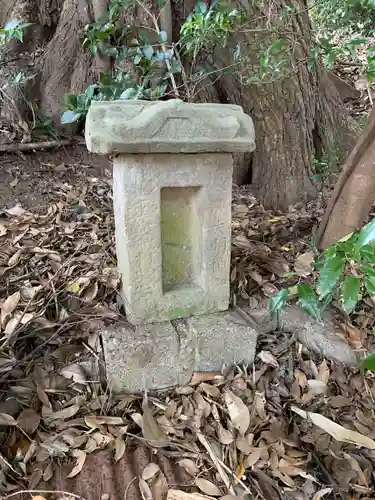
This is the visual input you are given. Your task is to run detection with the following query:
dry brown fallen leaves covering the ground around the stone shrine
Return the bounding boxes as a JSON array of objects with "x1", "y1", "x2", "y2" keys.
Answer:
[{"x1": 0, "y1": 148, "x2": 375, "y2": 500}]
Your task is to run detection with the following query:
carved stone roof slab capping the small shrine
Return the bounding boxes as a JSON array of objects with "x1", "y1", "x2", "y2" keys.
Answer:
[{"x1": 85, "y1": 99, "x2": 255, "y2": 155}]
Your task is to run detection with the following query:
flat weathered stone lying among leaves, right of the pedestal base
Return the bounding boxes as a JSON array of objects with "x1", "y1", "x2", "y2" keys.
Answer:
[{"x1": 246, "y1": 300, "x2": 359, "y2": 367}]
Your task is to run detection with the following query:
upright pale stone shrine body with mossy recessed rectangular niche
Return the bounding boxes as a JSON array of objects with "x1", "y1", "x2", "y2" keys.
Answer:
[{"x1": 113, "y1": 153, "x2": 232, "y2": 324}]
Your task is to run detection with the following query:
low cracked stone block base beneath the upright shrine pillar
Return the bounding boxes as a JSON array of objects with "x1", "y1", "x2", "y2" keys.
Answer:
[{"x1": 102, "y1": 310, "x2": 257, "y2": 392}]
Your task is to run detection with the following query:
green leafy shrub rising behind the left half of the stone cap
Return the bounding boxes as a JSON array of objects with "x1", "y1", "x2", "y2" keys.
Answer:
[{"x1": 61, "y1": 0, "x2": 185, "y2": 124}]
